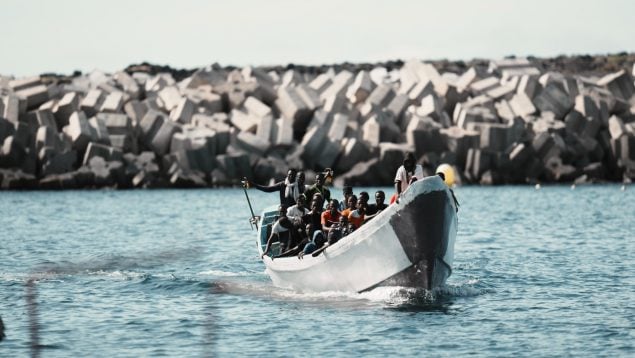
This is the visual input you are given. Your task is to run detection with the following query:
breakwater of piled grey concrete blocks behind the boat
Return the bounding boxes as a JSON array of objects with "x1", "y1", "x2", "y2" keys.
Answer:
[{"x1": 0, "y1": 53, "x2": 635, "y2": 189}]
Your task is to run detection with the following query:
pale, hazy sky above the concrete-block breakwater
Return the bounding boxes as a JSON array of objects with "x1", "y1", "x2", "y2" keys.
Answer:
[{"x1": 0, "y1": 0, "x2": 635, "y2": 77}]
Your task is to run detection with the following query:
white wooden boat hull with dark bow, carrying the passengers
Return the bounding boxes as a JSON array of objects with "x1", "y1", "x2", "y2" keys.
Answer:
[{"x1": 256, "y1": 176, "x2": 458, "y2": 292}]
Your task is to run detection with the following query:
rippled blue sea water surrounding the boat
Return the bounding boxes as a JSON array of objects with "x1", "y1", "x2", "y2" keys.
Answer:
[{"x1": 0, "y1": 185, "x2": 635, "y2": 357}]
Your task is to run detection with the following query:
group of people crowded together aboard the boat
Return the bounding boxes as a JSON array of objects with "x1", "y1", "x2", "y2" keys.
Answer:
[{"x1": 244, "y1": 153, "x2": 438, "y2": 259}]
